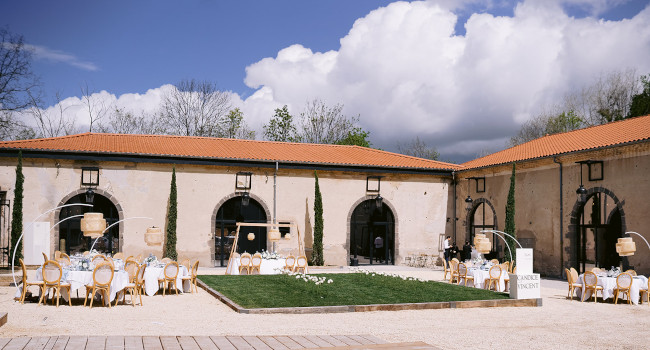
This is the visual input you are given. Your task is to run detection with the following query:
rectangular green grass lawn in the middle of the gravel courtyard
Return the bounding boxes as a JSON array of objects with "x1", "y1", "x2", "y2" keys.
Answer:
[{"x1": 199, "y1": 273, "x2": 508, "y2": 309}]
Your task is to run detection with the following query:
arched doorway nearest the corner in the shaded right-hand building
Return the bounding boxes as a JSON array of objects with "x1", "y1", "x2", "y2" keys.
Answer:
[{"x1": 464, "y1": 198, "x2": 501, "y2": 259}]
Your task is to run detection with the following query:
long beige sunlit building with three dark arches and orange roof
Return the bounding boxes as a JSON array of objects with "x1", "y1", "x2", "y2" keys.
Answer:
[{"x1": 0, "y1": 133, "x2": 459, "y2": 266}]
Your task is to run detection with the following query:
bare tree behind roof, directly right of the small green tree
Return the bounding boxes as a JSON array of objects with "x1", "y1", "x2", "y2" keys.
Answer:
[{"x1": 297, "y1": 99, "x2": 359, "y2": 144}]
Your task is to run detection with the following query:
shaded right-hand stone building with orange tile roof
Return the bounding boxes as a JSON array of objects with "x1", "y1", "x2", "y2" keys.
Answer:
[{"x1": 447, "y1": 116, "x2": 650, "y2": 276}]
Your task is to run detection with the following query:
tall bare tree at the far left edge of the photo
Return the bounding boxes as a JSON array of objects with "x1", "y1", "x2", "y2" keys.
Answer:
[{"x1": 0, "y1": 28, "x2": 40, "y2": 140}]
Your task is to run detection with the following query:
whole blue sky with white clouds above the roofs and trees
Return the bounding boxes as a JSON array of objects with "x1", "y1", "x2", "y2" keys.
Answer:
[{"x1": 0, "y1": 0, "x2": 650, "y2": 161}]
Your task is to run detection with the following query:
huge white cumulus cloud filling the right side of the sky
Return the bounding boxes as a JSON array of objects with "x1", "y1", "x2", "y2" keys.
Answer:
[{"x1": 237, "y1": 0, "x2": 650, "y2": 158}]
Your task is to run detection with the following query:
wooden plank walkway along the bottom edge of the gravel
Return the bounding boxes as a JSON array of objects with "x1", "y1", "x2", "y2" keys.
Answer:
[{"x1": 0, "y1": 335, "x2": 439, "y2": 350}]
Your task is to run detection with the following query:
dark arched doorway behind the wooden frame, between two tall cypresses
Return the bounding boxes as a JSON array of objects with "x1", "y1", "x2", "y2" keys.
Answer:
[{"x1": 214, "y1": 196, "x2": 267, "y2": 266}]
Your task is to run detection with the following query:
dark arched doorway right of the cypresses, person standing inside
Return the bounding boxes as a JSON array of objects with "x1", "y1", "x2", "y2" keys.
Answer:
[{"x1": 350, "y1": 199, "x2": 395, "y2": 265}]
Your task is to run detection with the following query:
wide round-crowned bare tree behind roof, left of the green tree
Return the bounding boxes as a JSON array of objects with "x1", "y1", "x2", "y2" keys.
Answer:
[{"x1": 160, "y1": 80, "x2": 230, "y2": 137}]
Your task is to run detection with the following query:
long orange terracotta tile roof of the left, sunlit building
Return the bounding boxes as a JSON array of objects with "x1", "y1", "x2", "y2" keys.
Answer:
[{"x1": 0, "y1": 133, "x2": 460, "y2": 170}]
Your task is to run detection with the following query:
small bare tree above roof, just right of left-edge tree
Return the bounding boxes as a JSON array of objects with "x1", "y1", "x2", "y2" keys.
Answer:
[{"x1": 26, "y1": 92, "x2": 75, "y2": 137}]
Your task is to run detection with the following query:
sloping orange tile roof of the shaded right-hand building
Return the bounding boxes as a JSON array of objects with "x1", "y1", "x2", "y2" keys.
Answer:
[{"x1": 461, "y1": 115, "x2": 650, "y2": 169}]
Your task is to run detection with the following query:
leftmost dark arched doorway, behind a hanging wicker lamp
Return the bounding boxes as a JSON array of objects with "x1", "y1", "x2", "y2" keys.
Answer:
[{"x1": 59, "y1": 193, "x2": 120, "y2": 255}]
